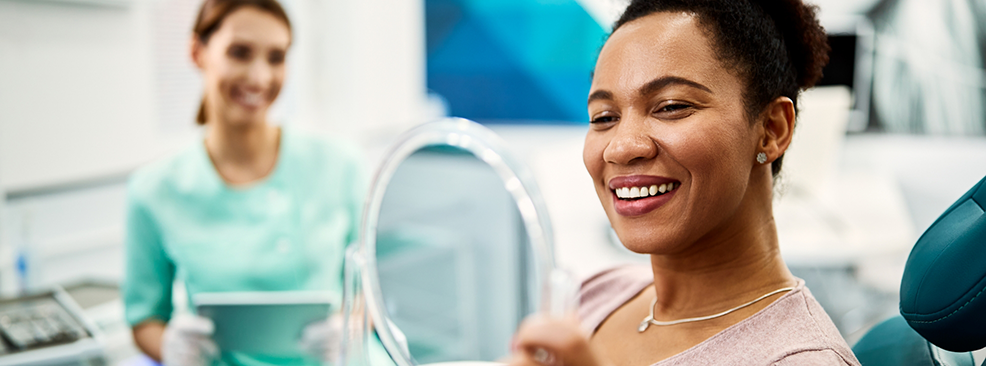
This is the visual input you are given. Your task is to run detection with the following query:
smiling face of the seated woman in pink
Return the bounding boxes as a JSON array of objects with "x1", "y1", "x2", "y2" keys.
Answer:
[{"x1": 583, "y1": 13, "x2": 759, "y2": 254}]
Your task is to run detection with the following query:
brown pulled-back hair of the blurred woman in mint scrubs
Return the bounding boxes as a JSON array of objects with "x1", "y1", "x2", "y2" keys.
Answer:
[{"x1": 192, "y1": 0, "x2": 291, "y2": 125}]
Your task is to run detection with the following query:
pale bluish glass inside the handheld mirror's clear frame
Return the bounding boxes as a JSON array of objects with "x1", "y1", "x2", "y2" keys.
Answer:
[{"x1": 376, "y1": 147, "x2": 534, "y2": 363}]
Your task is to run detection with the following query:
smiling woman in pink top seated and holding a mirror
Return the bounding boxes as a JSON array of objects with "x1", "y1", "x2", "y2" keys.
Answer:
[{"x1": 513, "y1": 0, "x2": 858, "y2": 365}]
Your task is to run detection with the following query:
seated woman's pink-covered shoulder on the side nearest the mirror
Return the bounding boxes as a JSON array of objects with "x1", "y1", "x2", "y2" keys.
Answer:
[{"x1": 579, "y1": 264, "x2": 654, "y2": 334}]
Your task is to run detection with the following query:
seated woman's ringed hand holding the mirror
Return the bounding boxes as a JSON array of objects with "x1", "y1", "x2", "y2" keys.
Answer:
[{"x1": 510, "y1": 315, "x2": 603, "y2": 366}]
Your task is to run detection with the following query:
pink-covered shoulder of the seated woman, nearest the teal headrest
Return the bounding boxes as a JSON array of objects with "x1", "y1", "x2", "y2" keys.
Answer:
[{"x1": 658, "y1": 280, "x2": 859, "y2": 366}]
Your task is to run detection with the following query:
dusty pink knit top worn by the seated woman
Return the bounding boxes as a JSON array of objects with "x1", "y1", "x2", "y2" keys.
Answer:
[{"x1": 579, "y1": 265, "x2": 859, "y2": 366}]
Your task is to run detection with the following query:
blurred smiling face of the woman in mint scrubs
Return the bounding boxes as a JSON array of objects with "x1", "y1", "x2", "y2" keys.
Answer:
[{"x1": 192, "y1": 6, "x2": 291, "y2": 125}]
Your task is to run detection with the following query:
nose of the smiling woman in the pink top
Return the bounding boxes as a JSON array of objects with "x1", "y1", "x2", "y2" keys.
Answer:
[{"x1": 603, "y1": 119, "x2": 658, "y2": 165}]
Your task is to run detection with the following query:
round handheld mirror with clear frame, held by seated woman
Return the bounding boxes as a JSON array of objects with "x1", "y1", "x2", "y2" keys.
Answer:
[{"x1": 343, "y1": 118, "x2": 576, "y2": 366}]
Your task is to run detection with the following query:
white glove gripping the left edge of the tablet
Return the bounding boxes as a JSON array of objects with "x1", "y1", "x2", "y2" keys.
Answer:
[{"x1": 161, "y1": 314, "x2": 219, "y2": 366}]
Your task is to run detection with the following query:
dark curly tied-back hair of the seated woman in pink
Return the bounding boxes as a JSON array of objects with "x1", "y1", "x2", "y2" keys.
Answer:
[{"x1": 613, "y1": 0, "x2": 831, "y2": 175}]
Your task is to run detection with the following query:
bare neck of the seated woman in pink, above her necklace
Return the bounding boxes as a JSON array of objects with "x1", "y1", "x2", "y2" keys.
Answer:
[{"x1": 651, "y1": 172, "x2": 796, "y2": 319}]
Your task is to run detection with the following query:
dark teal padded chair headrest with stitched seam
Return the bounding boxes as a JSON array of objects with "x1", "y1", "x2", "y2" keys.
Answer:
[{"x1": 900, "y1": 178, "x2": 986, "y2": 352}]
